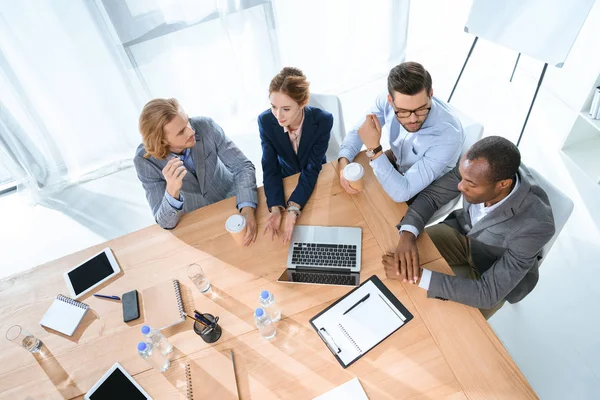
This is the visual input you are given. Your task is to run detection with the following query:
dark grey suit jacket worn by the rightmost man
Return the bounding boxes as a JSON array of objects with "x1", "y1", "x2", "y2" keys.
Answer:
[{"x1": 398, "y1": 165, "x2": 554, "y2": 309}]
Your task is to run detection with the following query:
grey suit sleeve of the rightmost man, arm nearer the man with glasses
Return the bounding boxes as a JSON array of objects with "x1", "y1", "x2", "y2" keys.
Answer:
[{"x1": 398, "y1": 165, "x2": 462, "y2": 233}]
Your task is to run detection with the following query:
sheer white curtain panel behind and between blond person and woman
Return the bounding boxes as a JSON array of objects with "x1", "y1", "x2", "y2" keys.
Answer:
[{"x1": 120, "y1": 0, "x2": 280, "y2": 128}]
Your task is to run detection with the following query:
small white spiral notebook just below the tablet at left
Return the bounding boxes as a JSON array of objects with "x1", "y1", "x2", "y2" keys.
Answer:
[{"x1": 40, "y1": 294, "x2": 90, "y2": 336}]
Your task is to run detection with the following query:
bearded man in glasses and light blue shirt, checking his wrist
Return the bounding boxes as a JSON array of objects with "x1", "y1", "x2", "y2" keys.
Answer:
[{"x1": 339, "y1": 62, "x2": 465, "y2": 202}]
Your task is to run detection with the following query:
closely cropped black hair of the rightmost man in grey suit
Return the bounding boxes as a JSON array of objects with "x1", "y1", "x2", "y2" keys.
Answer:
[{"x1": 466, "y1": 136, "x2": 521, "y2": 182}]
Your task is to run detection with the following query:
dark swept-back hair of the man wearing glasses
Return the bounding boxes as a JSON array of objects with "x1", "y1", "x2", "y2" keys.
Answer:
[{"x1": 388, "y1": 61, "x2": 432, "y2": 97}]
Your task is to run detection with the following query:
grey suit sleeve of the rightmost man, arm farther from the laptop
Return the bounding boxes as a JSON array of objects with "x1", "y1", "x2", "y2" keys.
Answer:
[{"x1": 427, "y1": 221, "x2": 554, "y2": 309}]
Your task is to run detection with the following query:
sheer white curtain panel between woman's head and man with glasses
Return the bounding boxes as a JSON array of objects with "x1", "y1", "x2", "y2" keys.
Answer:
[{"x1": 273, "y1": 0, "x2": 410, "y2": 94}]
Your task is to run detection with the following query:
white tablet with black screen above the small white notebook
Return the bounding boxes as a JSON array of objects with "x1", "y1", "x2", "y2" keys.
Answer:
[{"x1": 64, "y1": 247, "x2": 121, "y2": 299}]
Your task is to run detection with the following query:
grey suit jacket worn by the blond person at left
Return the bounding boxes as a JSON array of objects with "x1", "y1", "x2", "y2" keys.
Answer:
[{"x1": 133, "y1": 117, "x2": 258, "y2": 229}]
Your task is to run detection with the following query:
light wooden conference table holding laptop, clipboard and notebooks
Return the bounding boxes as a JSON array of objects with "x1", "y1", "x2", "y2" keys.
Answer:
[{"x1": 0, "y1": 154, "x2": 537, "y2": 399}]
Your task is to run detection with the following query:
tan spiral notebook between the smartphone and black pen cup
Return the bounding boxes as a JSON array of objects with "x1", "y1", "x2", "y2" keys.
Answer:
[{"x1": 142, "y1": 279, "x2": 185, "y2": 329}]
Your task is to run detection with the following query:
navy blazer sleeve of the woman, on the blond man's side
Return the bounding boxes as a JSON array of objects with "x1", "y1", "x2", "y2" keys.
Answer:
[{"x1": 258, "y1": 117, "x2": 285, "y2": 209}]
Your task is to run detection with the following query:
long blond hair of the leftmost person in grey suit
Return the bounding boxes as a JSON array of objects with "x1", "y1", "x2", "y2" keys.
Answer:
[{"x1": 139, "y1": 99, "x2": 183, "y2": 160}]
